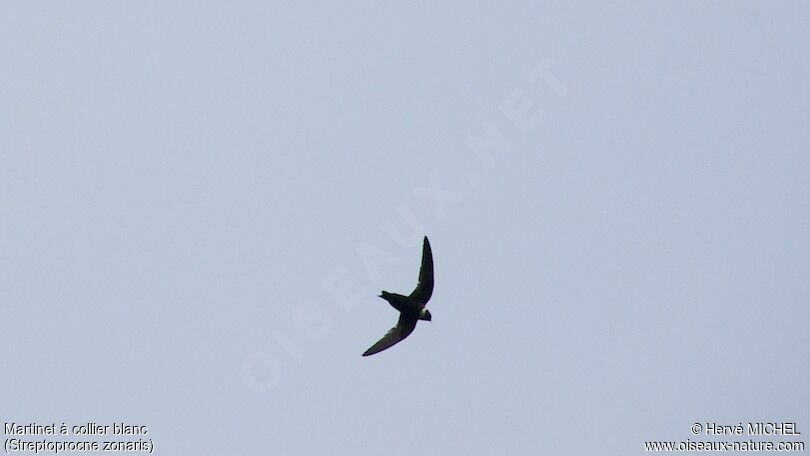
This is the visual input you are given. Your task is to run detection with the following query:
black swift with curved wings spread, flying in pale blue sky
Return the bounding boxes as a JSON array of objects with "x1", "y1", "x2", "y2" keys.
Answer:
[{"x1": 363, "y1": 236, "x2": 433, "y2": 356}]
